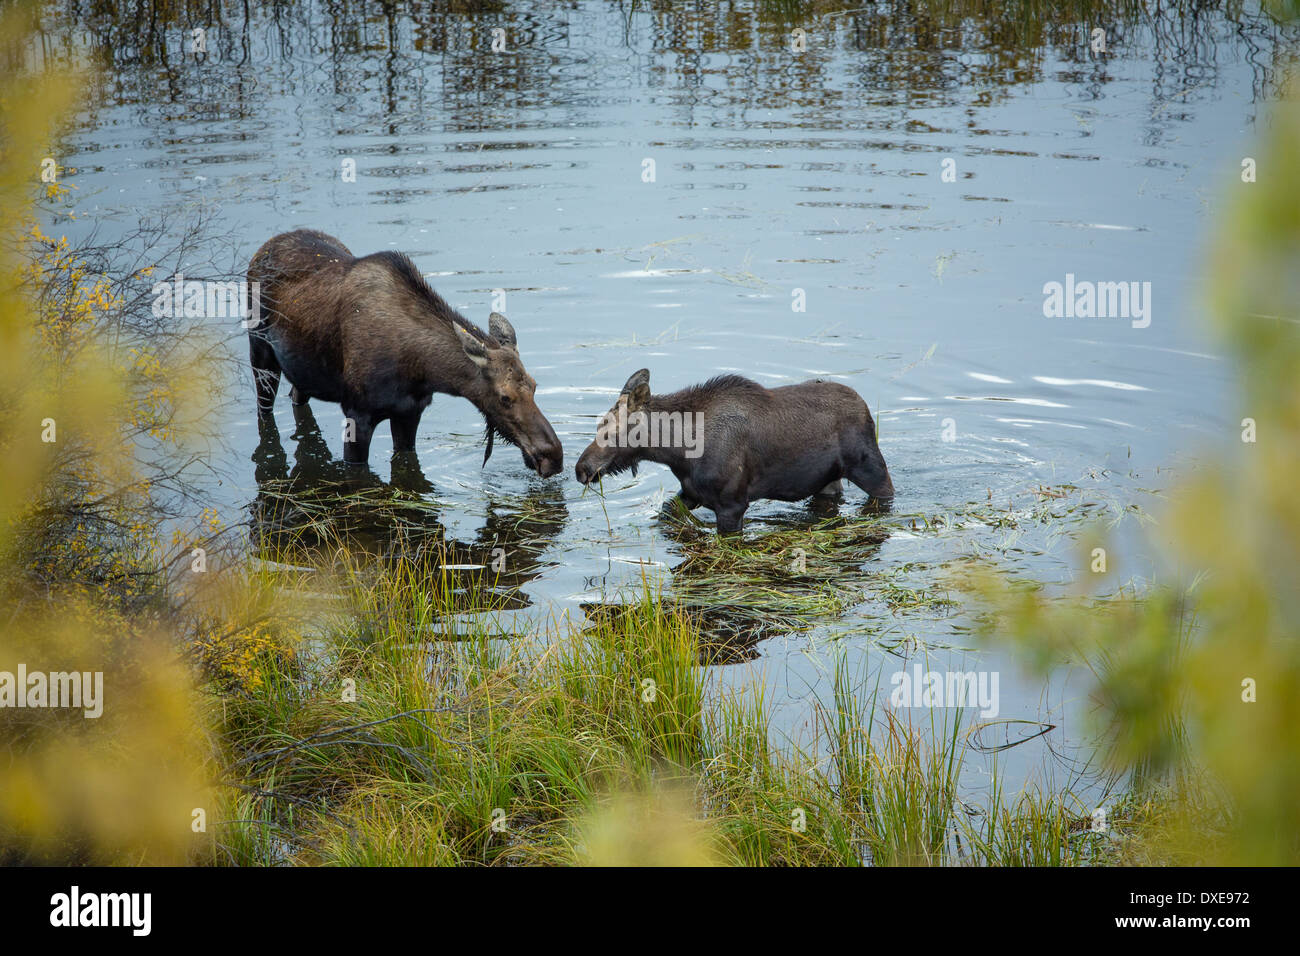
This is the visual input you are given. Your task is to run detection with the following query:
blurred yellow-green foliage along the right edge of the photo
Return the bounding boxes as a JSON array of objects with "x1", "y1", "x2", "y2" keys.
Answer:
[{"x1": 976, "y1": 83, "x2": 1300, "y2": 865}]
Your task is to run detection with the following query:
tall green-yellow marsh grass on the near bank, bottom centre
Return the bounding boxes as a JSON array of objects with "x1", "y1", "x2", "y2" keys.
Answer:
[{"x1": 209, "y1": 530, "x2": 1118, "y2": 865}]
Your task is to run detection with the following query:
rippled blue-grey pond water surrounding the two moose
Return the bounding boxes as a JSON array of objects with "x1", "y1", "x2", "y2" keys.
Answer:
[{"x1": 47, "y1": 0, "x2": 1287, "y2": 801}]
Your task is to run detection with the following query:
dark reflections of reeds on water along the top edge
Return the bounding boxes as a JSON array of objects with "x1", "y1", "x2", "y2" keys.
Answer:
[{"x1": 47, "y1": 0, "x2": 1287, "y2": 123}]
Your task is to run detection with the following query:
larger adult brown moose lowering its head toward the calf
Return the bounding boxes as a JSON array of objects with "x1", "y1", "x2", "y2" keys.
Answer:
[{"x1": 248, "y1": 229, "x2": 564, "y2": 477}]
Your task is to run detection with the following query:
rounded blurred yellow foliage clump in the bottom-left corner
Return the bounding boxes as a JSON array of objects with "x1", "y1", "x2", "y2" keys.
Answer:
[{"x1": 0, "y1": 593, "x2": 212, "y2": 865}]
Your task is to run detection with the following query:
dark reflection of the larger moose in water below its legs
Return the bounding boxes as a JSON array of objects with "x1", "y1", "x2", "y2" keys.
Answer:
[{"x1": 250, "y1": 405, "x2": 568, "y2": 610}]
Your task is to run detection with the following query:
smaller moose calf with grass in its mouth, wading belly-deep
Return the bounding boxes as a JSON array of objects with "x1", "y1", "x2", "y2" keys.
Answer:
[{"x1": 576, "y1": 368, "x2": 894, "y2": 532}]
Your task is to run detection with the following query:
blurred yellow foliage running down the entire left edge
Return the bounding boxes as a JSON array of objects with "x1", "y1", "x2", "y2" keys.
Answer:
[{"x1": 0, "y1": 4, "x2": 205, "y2": 864}]
